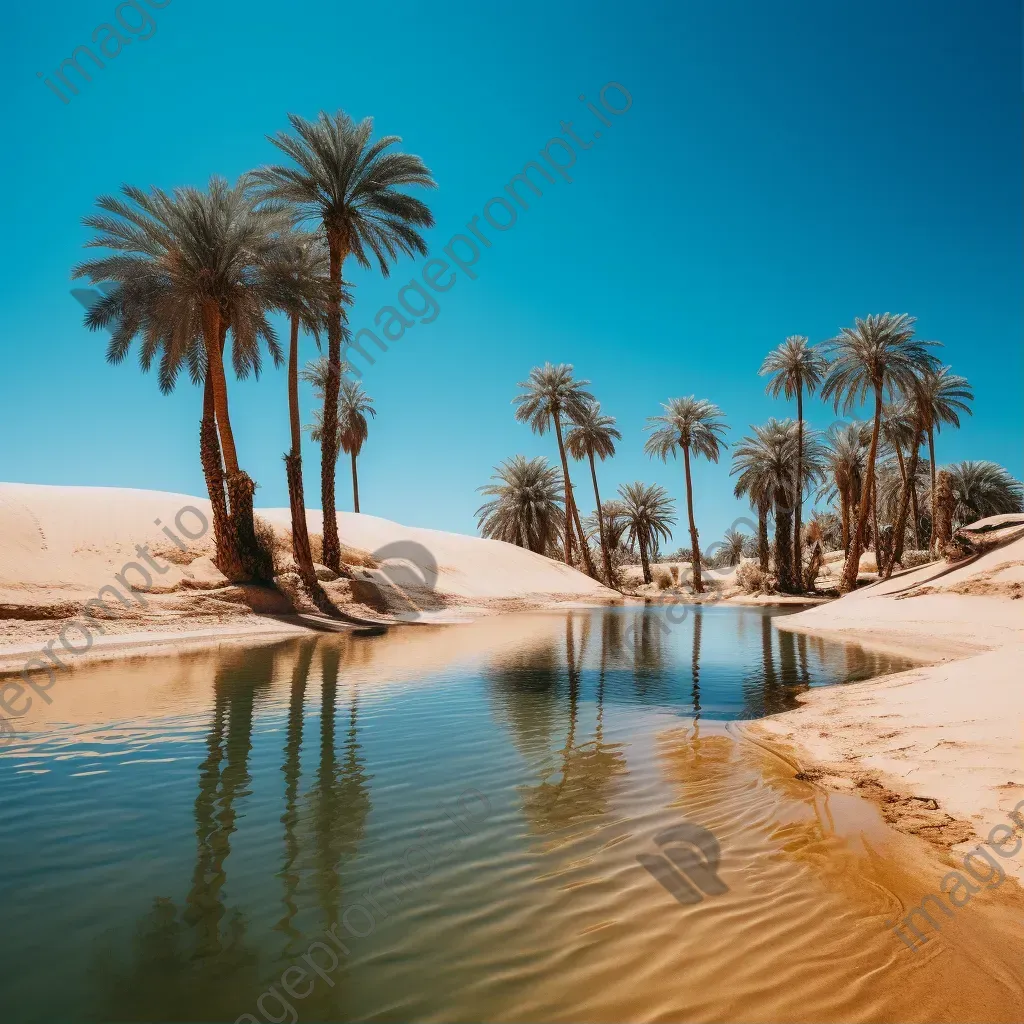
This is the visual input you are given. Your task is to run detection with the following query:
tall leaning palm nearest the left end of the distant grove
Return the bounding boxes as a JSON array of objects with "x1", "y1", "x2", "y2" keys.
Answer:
[{"x1": 512, "y1": 362, "x2": 596, "y2": 579}]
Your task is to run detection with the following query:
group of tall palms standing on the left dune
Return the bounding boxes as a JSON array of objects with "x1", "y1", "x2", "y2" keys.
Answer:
[{"x1": 73, "y1": 111, "x2": 435, "y2": 613}]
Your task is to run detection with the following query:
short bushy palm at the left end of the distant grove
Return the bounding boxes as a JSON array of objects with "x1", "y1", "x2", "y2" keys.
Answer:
[{"x1": 476, "y1": 455, "x2": 565, "y2": 555}]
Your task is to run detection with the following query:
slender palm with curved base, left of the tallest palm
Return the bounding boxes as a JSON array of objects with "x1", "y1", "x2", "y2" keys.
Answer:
[{"x1": 260, "y1": 231, "x2": 337, "y2": 615}]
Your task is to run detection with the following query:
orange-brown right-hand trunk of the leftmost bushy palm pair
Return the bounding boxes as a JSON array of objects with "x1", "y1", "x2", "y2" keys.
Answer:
[{"x1": 203, "y1": 301, "x2": 264, "y2": 582}]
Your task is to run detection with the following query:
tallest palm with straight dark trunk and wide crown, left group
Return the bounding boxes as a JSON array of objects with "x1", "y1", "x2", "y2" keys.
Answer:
[{"x1": 254, "y1": 111, "x2": 436, "y2": 573}]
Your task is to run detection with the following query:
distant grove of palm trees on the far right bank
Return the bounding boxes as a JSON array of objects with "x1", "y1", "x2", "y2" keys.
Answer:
[{"x1": 477, "y1": 313, "x2": 1024, "y2": 593}]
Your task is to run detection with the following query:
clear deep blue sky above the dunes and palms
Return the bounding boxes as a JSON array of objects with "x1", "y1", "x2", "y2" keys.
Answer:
[{"x1": 0, "y1": 0, "x2": 1024, "y2": 543}]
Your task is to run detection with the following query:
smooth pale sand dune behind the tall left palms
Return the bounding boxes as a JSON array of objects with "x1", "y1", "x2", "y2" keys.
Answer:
[{"x1": 0, "y1": 483, "x2": 618, "y2": 671}]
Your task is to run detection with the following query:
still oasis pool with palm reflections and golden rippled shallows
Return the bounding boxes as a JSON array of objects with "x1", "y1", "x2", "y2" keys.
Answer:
[{"x1": 0, "y1": 607, "x2": 1021, "y2": 1024}]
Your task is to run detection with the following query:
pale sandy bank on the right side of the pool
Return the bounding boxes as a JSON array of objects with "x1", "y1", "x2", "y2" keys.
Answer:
[{"x1": 746, "y1": 520, "x2": 1024, "y2": 880}]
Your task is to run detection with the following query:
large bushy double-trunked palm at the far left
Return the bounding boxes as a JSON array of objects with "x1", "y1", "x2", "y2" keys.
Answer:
[{"x1": 72, "y1": 176, "x2": 290, "y2": 579}]
